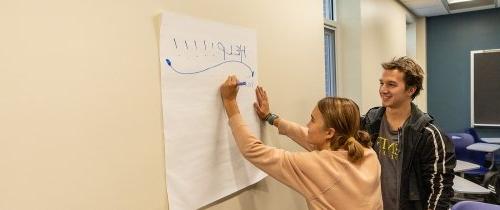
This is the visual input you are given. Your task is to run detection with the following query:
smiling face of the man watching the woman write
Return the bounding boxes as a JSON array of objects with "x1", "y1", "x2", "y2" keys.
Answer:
[{"x1": 378, "y1": 69, "x2": 415, "y2": 108}]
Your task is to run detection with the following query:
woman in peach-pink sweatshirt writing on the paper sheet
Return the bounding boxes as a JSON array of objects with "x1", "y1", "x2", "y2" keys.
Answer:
[{"x1": 220, "y1": 76, "x2": 382, "y2": 210}]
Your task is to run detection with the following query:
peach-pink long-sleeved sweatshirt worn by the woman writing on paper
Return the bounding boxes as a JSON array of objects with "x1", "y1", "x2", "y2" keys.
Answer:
[{"x1": 229, "y1": 114, "x2": 383, "y2": 210}]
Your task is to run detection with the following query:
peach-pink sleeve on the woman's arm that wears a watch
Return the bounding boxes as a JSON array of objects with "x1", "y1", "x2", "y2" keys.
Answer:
[{"x1": 278, "y1": 119, "x2": 315, "y2": 151}]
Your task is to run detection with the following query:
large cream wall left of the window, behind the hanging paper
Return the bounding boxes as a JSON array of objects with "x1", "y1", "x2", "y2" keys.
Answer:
[{"x1": 0, "y1": 0, "x2": 324, "y2": 210}]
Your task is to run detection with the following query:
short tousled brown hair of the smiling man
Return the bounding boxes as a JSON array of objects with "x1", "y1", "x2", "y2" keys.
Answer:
[{"x1": 382, "y1": 56, "x2": 424, "y2": 99}]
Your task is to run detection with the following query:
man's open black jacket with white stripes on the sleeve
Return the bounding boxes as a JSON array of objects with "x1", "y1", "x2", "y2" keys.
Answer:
[{"x1": 361, "y1": 103, "x2": 456, "y2": 210}]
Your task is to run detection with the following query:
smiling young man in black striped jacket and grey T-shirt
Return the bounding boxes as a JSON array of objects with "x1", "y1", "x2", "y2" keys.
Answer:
[{"x1": 362, "y1": 57, "x2": 456, "y2": 210}]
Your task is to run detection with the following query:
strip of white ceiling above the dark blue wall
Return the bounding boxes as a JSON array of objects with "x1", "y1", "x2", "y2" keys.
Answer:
[{"x1": 399, "y1": 0, "x2": 500, "y2": 17}]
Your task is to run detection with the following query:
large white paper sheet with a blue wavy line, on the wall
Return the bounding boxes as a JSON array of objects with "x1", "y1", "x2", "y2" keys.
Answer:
[{"x1": 159, "y1": 12, "x2": 266, "y2": 210}]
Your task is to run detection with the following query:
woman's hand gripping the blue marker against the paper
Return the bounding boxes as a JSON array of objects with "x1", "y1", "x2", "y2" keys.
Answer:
[{"x1": 219, "y1": 75, "x2": 240, "y2": 118}]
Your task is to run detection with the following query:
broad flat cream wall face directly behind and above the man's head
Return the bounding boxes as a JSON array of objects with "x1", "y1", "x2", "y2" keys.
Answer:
[{"x1": 360, "y1": 0, "x2": 406, "y2": 111}]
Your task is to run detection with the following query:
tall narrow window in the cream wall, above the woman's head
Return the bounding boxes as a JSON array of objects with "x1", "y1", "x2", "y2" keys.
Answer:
[{"x1": 323, "y1": 0, "x2": 337, "y2": 96}]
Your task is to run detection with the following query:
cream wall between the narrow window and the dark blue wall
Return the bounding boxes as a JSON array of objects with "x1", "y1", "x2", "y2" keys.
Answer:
[{"x1": 337, "y1": 0, "x2": 426, "y2": 113}]
